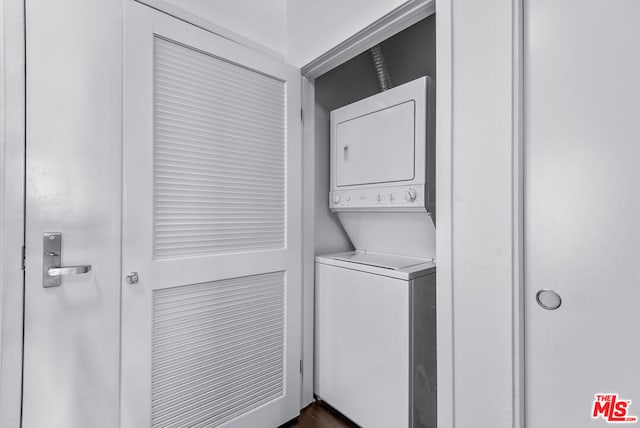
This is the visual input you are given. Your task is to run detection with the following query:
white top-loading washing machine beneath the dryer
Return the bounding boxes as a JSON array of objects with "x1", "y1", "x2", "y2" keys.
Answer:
[{"x1": 315, "y1": 251, "x2": 436, "y2": 428}]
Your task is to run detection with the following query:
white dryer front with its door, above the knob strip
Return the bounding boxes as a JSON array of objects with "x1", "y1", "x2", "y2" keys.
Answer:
[{"x1": 331, "y1": 76, "x2": 430, "y2": 191}]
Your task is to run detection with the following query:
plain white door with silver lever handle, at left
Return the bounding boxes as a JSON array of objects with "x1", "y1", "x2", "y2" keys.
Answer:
[{"x1": 22, "y1": 0, "x2": 122, "y2": 428}]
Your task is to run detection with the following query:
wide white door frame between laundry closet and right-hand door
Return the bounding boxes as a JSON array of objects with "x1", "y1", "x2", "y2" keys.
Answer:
[{"x1": 444, "y1": 0, "x2": 525, "y2": 422}]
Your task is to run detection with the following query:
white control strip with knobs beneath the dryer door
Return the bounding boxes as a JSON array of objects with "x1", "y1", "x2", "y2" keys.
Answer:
[{"x1": 329, "y1": 186, "x2": 425, "y2": 211}]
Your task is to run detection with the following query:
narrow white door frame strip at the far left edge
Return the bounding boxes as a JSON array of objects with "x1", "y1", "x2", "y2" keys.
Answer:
[{"x1": 0, "y1": 0, "x2": 25, "y2": 428}]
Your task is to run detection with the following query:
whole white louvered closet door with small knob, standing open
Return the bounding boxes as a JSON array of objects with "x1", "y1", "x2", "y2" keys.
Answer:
[{"x1": 122, "y1": 2, "x2": 302, "y2": 428}]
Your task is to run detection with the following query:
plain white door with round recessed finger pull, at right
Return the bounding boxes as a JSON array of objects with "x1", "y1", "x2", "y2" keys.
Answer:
[{"x1": 525, "y1": 0, "x2": 640, "y2": 428}]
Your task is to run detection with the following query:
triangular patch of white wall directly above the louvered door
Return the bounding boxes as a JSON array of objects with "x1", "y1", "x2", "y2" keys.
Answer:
[{"x1": 166, "y1": 0, "x2": 287, "y2": 57}]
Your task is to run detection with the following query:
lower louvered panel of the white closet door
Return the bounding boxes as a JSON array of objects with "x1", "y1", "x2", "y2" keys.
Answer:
[{"x1": 152, "y1": 272, "x2": 285, "y2": 428}]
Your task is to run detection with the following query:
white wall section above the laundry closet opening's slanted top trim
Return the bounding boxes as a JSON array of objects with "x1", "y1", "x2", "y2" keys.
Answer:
[{"x1": 287, "y1": 0, "x2": 411, "y2": 67}]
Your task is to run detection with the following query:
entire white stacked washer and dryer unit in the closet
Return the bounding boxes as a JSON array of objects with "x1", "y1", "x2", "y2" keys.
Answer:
[{"x1": 315, "y1": 76, "x2": 436, "y2": 428}]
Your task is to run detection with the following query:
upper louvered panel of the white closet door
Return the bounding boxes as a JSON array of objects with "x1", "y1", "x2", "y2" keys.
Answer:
[{"x1": 154, "y1": 37, "x2": 286, "y2": 260}]
